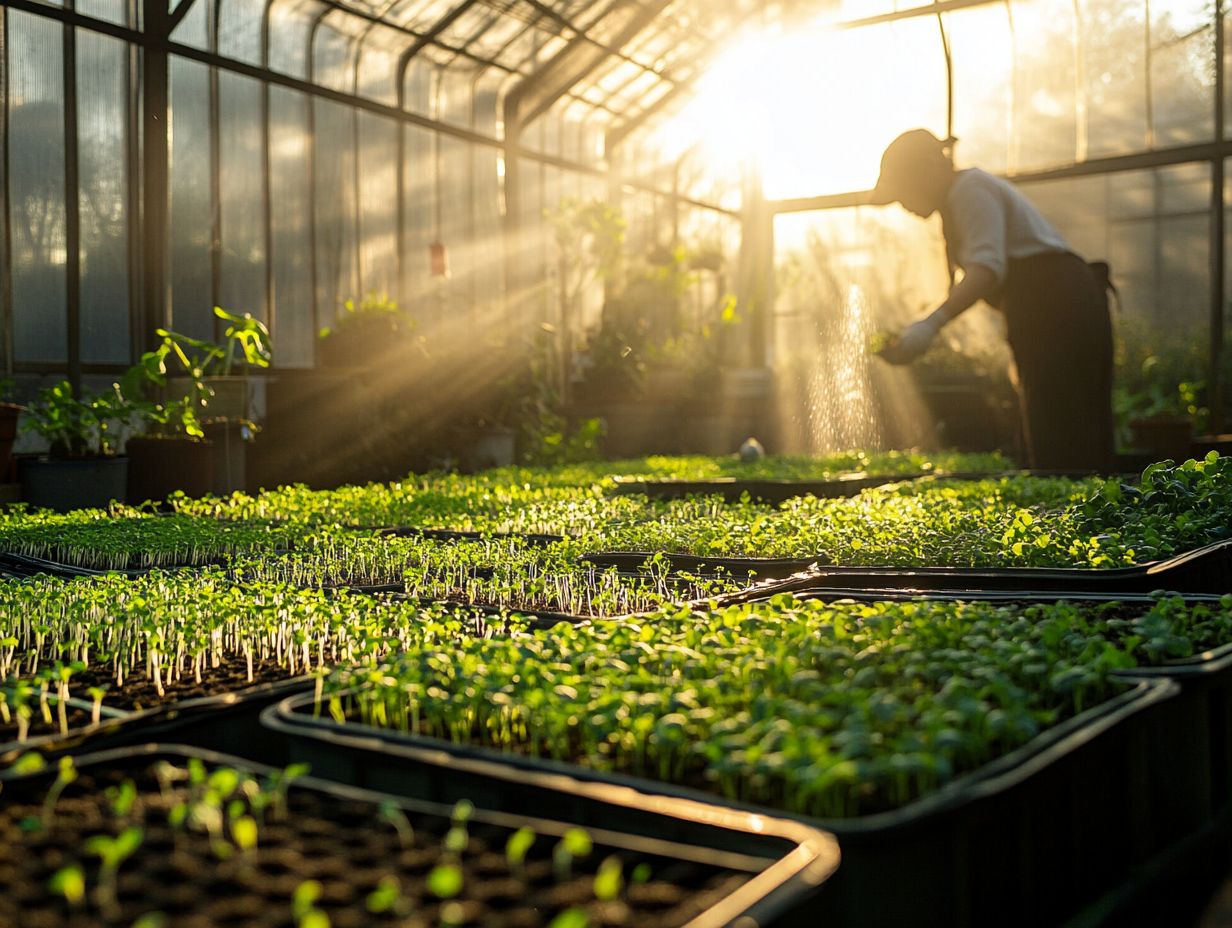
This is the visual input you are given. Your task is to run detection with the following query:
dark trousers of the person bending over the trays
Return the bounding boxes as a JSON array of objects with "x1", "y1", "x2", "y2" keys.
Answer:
[{"x1": 1000, "y1": 253, "x2": 1114, "y2": 472}]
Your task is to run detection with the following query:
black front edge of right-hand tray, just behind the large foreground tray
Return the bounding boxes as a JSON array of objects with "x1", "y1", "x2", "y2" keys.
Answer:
[{"x1": 694, "y1": 540, "x2": 1232, "y2": 594}]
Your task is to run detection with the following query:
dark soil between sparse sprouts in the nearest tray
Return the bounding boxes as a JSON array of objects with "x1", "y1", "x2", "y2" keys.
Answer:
[{"x1": 0, "y1": 755, "x2": 749, "y2": 928}]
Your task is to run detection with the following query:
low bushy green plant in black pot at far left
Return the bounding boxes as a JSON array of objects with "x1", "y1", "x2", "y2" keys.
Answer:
[{"x1": 21, "y1": 381, "x2": 138, "y2": 513}]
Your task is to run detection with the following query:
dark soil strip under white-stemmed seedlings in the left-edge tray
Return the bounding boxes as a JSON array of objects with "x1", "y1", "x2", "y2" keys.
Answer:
[{"x1": 0, "y1": 656, "x2": 290, "y2": 744}]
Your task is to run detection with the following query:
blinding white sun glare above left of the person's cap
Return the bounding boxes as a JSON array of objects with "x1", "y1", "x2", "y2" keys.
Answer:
[{"x1": 660, "y1": 16, "x2": 945, "y2": 198}]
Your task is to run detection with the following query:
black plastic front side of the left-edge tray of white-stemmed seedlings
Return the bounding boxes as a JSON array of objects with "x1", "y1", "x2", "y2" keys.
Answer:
[{"x1": 0, "y1": 677, "x2": 315, "y2": 769}]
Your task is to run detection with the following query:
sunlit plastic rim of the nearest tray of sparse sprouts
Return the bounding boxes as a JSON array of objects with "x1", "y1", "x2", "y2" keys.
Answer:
[{"x1": 0, "y1": 743, "x2": 839, "y2": 928}]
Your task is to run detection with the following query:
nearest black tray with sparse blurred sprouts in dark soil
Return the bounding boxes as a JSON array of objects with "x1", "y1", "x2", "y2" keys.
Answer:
[{"x1": 0, "y1": 744, "x2": 838, "y2": 928}]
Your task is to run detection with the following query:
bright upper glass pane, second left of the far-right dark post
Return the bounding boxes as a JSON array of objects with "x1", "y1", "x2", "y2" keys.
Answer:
[{"x1": 1080, "y1": 0, "x2": 1147, "y2": 158}]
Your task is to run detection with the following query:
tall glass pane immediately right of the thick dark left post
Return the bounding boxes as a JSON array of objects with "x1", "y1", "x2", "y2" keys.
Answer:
[{"x1": 170, "y1": 54, "x2": 214, "y2": 339}]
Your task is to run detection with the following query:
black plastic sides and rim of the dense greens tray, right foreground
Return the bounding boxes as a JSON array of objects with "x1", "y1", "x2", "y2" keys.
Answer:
[{"x1": 262, "y1": 680, "x2": 1178, "y2": 926}]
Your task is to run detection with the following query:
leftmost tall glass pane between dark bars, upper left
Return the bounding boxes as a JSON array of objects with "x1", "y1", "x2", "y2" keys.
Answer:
[{"x1": 7, "y1": 10, "x2": 68, "y2": 361}]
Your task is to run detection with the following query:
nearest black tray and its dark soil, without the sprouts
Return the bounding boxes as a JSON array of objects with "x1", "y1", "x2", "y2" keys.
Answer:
[{"x1": 0, "y1": 744, "x2": 838, "y2": 928}]
